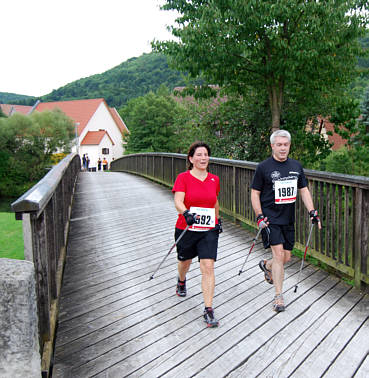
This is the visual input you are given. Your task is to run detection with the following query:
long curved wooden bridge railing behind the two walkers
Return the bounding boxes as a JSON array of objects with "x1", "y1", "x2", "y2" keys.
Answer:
[{"x1": 111, "y1": 153, "x2": 369, "y2": 288}]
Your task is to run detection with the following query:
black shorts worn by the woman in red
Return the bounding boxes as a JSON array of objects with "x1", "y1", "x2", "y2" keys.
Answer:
[{"x1": 174, "y1": 227, "x2": 219, "y2": 261}]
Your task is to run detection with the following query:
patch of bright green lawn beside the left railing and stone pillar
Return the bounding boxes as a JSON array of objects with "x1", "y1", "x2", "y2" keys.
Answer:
[{"x1": 0, "y1": 212, "x2": 24, "y2": 260}]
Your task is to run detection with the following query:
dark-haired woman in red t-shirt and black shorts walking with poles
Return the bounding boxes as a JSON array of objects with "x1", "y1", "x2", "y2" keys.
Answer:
[{"x1": 172, "y1": 142, "x2": 222, "y2": 327}]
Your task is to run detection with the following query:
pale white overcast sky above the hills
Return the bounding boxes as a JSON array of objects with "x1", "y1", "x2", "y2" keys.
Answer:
[{"x1": 0, "y1": 0, "x2": 175, "y2": 96}]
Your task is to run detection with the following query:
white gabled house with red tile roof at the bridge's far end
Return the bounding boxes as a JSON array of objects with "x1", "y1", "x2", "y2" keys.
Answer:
[{"x1": 34, "y1": 98, "x2": 129, "y2": 169}]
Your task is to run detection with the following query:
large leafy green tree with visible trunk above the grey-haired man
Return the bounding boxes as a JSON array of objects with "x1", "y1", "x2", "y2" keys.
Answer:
[{"x1": 153, "y1": 0, "x2": 368, "y2": 130}]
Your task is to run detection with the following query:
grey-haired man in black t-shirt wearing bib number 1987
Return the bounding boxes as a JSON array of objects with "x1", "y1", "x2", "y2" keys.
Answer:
[{"x1": 251, "y1": 130, "x2": 321, "y2": 312}]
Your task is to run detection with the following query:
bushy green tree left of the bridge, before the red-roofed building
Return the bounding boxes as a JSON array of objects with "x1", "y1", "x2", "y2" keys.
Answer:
[{"x1": 0, "y1": 110, "x2": 74, "y2": 197}]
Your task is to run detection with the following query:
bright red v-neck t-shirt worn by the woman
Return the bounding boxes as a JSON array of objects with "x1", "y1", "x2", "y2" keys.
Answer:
[{"x1": 172, "y1": 171, "x2": 220, "y2": 230}]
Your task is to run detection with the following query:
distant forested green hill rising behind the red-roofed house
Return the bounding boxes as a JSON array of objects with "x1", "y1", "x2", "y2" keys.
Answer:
[{"x1": 0, "y1": 53, "x2": 185, "y2": 108}]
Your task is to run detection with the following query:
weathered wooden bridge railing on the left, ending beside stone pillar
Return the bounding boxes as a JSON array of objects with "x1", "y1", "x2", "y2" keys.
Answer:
[{"x1": 11, "y1": 153, "x2": 81, "y2": 374}]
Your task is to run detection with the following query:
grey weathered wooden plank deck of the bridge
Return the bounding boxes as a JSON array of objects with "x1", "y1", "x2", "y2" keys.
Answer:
[{"x1": 53, "y1": 172, "x2": 369, "y2": 378}]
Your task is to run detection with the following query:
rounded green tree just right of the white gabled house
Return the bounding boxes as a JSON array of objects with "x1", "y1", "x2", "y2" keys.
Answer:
[{"x1": 119, "y1": 87, "x2": 180, "y2": 154}]
